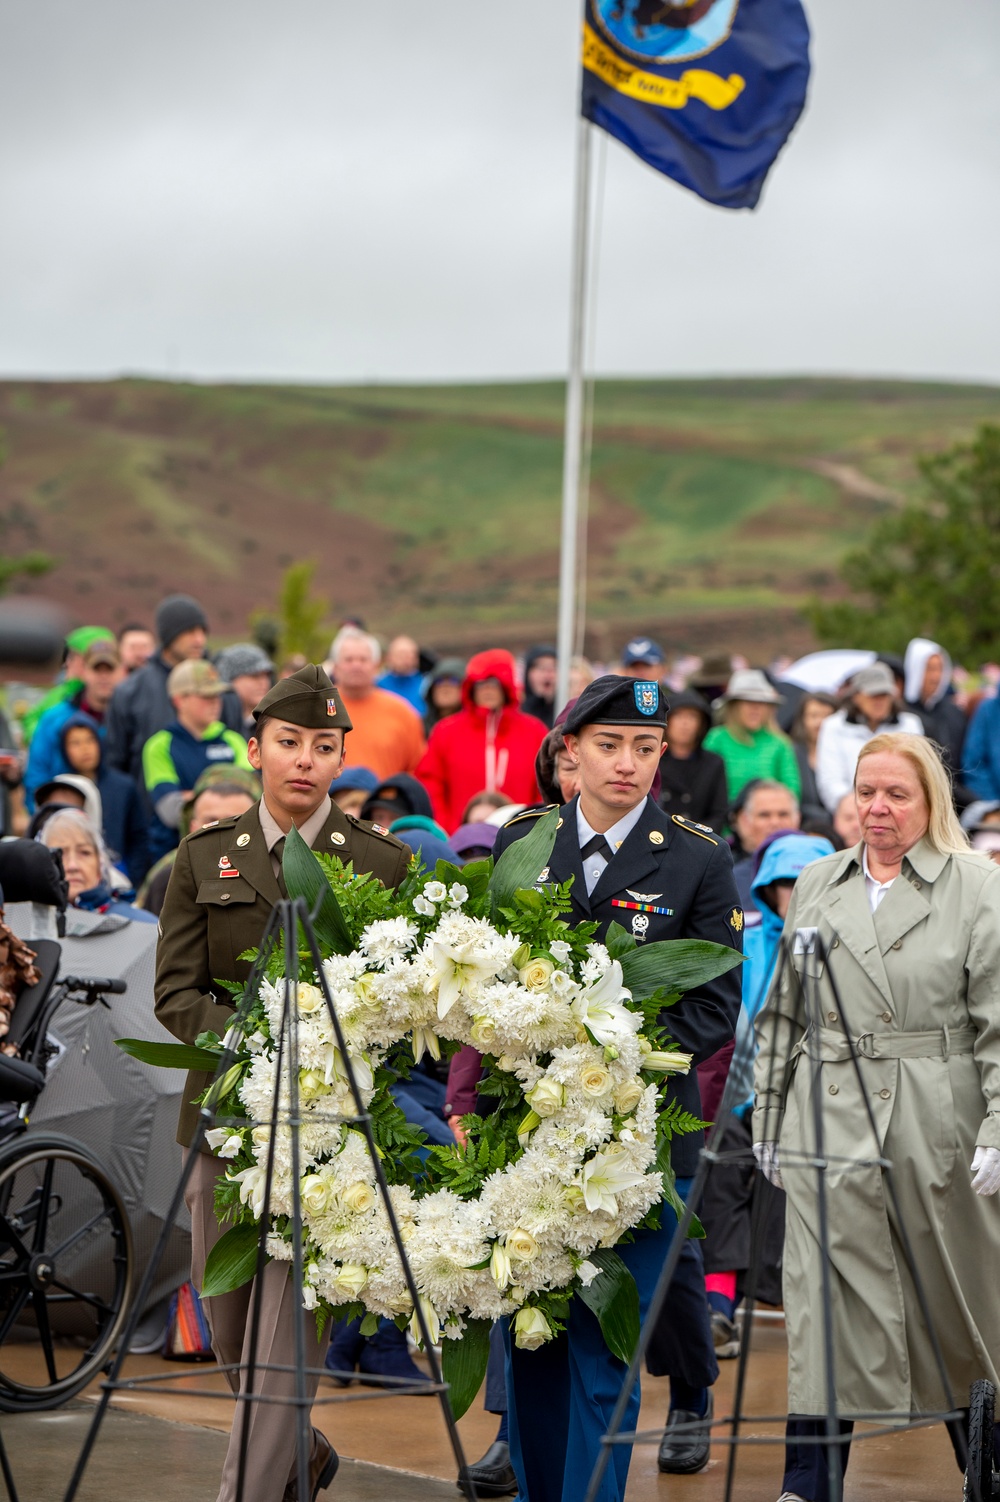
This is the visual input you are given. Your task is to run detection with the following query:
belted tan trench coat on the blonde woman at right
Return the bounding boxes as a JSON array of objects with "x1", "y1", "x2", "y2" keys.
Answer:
[{"x1": 754, "y1": 840, "x2": 1000, "y2": 1418}]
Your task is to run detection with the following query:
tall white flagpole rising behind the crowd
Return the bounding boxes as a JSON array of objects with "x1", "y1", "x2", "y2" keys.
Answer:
[{"x1": 556, "y1": 114, "x2": 590, "y2": 709}]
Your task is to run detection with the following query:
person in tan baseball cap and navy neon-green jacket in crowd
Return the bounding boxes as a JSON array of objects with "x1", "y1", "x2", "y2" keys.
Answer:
[{"x1": 143, "y1": 658, "x2": 251, "y2": 861}]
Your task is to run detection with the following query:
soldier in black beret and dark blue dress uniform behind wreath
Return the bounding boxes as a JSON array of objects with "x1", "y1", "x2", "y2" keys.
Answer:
[{"x1": 494, "y1": 674, "x2": 743, "y2": 1497}]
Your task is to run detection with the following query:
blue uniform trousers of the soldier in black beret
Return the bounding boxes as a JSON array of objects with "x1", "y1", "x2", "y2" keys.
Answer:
[{"x1": 503, "y1": 1179, "x2": 719, "y2": 1502}]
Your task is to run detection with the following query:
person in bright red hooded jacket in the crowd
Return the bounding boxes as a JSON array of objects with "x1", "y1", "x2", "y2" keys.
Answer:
[{"x1": 416, "y1": 647, "x2": 547, "y2": 834}]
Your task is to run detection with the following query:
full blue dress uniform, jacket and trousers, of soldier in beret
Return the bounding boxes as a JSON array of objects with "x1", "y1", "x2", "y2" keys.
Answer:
[{"x1": 494, "y1": 798, "x2": 743, "y2": 1502}]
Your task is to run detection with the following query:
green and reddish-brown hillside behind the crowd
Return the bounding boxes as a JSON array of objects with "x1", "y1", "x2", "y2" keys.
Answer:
[{"x1": 0, "y1": 379, "x2": 1000, "y2": 656}]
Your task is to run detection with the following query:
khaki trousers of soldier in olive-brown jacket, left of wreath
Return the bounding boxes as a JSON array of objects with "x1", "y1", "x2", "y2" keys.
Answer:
[{"x1": 185, "y1": 1152, "x2": 329, "y2": 1502}]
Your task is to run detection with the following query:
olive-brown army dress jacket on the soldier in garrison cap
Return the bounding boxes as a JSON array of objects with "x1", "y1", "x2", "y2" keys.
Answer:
[{"x1": 155, "y1": 804, "x2": 410, "y2": 1151}]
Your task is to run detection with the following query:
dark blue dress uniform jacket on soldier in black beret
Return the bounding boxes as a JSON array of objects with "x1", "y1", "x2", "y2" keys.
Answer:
[{"x1": 494, "y1": 798, "x2": 743, "y2": 1178}]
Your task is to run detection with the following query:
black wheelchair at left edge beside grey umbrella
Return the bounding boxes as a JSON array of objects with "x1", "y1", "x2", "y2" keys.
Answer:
[{"x1": 0, "y1": 939, "x2": 135, "y2": 1413}]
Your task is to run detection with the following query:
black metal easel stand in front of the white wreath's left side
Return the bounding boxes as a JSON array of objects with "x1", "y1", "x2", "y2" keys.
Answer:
[{"x1": 59, "y1": 898, "x2": 476, "y2": 1502}]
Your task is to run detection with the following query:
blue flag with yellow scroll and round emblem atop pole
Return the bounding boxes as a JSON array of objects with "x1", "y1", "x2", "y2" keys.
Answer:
[{"x1": 583, "y1": 0, "x2": 809, "y2": 209}]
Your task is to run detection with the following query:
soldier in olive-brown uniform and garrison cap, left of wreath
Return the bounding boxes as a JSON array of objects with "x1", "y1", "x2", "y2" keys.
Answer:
[{"x1": 155, "y1": 664, "x2": 410, "y2": 1502}]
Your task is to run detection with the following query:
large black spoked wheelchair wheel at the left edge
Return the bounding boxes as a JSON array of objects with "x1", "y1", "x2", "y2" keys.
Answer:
[{"x1": 0, "y1": 1134, "x2": 134, "y2": 1413}]
